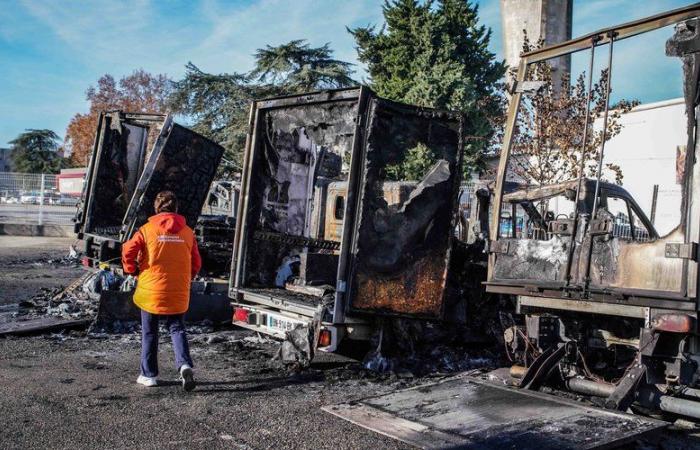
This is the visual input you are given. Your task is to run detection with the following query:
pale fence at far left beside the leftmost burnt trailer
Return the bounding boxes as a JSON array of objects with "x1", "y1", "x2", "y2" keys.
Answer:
[{"x1": 0, "y1": 172, "x2": 79, "y2": 225}]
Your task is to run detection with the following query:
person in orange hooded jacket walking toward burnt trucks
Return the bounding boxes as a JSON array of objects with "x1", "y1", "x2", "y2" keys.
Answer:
[{"x1": 122, "y1": 191, "x2": 202, "y2": 391}]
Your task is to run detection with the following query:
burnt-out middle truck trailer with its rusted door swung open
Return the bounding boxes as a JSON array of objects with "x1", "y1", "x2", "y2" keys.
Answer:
[{"x1": 230, "y1": 87, "x2": 463, "y2": 351}]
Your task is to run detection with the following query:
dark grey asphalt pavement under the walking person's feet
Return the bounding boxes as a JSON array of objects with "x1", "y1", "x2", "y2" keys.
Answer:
[{"x1": 0, "y1": 331, "x2": 416, "y2": 449}]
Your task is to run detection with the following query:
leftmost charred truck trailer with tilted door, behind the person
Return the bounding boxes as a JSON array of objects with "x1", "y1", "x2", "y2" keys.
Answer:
[{"x1": 75, "y1": 111, "x2": 230, "y2": 320}]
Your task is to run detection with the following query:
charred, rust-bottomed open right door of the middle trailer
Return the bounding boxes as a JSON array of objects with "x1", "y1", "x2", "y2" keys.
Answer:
[{"x1": 347, "y1": 98, "x2": 463, "y2": 319}]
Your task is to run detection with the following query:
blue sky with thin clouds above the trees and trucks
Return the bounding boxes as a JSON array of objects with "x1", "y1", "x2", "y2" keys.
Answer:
[{"x1": 0, "y1": 0, "x2": 692, "y2": 147}]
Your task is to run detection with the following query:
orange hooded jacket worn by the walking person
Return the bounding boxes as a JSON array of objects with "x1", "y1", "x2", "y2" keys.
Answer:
[{"x1": 122, "y1": 213, "x2": 202, "y2": 314}]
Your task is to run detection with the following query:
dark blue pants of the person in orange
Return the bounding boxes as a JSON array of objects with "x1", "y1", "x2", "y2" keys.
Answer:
[{"x1": 141, "y1": 310, "x2": 194, "y2": 377}]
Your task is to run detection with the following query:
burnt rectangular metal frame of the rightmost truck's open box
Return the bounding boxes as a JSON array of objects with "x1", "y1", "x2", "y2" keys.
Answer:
[{"x1": 486, "y1": 3, "x2": 700, "y2": 310}]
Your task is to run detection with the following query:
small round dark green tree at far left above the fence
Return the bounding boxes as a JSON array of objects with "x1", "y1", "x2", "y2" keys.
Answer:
[{"x1": 10, "y1": 129, "x2": 70, "y2": 173}]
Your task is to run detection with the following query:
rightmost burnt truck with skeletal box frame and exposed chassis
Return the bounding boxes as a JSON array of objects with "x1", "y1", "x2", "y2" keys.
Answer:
[{"x1": 486, "y1": 4, "x2": 700, "y2": 418}]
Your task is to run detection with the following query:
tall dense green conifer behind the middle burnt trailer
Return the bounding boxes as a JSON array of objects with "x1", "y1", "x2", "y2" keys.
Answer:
[{"x1": 348, "y1": 0, "x2": 505, "y2": 178}]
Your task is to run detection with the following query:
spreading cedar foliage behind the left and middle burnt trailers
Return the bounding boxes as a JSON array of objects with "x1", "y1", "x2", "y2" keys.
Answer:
[{"x1": 170, "y1": 40, "x2": 355, "y2": 176}]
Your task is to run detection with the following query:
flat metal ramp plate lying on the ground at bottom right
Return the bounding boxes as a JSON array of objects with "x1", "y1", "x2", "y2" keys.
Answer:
[{"x1": 323, "y1": 376, "x2": 667, "y2": 450}]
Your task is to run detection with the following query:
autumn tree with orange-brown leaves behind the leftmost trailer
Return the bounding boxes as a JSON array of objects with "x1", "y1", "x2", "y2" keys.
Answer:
[{"x1": 65, "y1": 69, "x2": 170, "y2": 166}]
